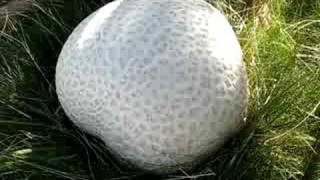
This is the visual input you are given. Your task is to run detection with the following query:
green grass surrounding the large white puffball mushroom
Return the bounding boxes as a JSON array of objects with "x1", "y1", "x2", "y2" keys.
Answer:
[{"x1": 0, "y1": 0, "x2": 320, "y2": 180}]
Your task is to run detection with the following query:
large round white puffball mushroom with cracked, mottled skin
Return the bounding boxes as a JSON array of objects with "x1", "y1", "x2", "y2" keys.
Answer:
[{"x1": 56, "y1": 0, "x2": 247, "y2": 173}]
